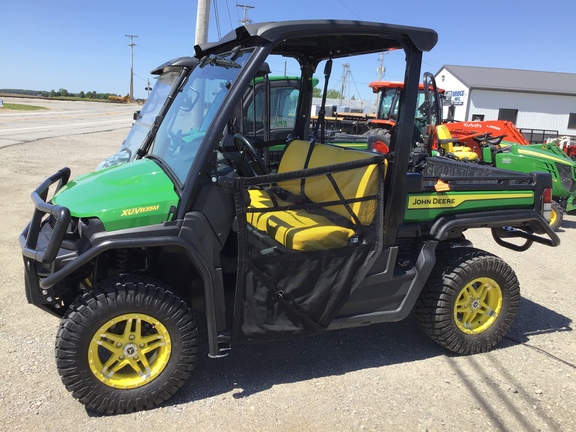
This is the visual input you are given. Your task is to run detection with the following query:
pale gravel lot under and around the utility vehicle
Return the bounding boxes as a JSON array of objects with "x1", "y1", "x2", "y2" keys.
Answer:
[{"x1": 0, "y1": 129, "x2": 576, "y2": 431}]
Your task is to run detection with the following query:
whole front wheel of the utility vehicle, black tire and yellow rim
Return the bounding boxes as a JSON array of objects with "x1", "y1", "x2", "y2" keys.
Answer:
[{"x1": 56, "y1": 279, "x2": 198, "y2": 414}]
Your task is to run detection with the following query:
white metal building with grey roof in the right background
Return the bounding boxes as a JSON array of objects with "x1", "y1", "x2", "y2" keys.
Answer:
[{"x1": 436, "y1": 65, "x2": 576, "y2": 141}]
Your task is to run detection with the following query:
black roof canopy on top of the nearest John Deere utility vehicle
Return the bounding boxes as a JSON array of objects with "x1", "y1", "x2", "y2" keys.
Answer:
[{"x1": 194, "y1": 20, "x2": 438, "y2": 61}]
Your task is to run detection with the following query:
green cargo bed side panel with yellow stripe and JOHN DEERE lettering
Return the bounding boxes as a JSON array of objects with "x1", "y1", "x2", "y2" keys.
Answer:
[{"x1": 404, "y1": 191, "x2": 534, "y2": 222}]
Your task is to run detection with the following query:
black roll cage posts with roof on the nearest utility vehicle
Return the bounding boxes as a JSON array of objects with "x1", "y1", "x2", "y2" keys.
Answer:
[{"x1": 177, "y1": 20, "x2": 438, "y2": 244}]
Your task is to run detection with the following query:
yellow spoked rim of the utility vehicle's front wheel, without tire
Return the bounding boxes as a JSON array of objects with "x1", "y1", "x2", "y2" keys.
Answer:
[{"x1": 88, "y1": 313, "x2": 172, "y2": 389}]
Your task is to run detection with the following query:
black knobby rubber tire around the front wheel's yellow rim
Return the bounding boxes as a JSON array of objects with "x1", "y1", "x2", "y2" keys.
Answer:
[{"x1": 55, "y1": 278, "x2": 198, "y2": 414}]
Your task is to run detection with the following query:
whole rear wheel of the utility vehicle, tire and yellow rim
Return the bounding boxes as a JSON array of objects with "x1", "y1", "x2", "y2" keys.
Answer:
[{"x1": 415, "y1": 247, "x2": 520, "y2": 354}]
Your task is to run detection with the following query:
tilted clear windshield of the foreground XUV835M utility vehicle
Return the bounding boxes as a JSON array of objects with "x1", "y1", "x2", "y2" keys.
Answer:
[{"x1": 149, "y1": 51, "x2": 251, "y2": 183}]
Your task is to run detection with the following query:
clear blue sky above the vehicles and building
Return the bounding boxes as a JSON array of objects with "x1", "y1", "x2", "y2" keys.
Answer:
[{"x1": 0, "y1": 0, "x2": 576, "y2": 97}]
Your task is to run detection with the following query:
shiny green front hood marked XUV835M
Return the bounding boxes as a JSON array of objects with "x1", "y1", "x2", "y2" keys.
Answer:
[{"x1": 53, "y1": 159, "x2": 178, "y2": 231}]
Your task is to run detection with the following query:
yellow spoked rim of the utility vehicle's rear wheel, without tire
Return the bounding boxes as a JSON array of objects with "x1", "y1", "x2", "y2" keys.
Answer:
[{"x1": 454, "y1": 277, "x2": 502, "y2": 334}]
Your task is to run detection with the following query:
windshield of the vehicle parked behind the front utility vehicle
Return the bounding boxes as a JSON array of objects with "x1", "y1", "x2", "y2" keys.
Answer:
[{"x1": 97, "y1": 71, "x2": 179, "y2": 170}]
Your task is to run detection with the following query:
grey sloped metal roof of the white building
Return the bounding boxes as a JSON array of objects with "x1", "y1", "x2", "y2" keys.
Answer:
[{"x1": 436, "y1": 65, "x2": 576, "y2": 95}]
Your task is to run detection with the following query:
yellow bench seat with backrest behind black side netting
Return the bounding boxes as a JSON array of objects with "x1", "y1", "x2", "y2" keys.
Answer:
[{"x1": 247, "y1": 140, "x2": 387, "y2": 251}]
